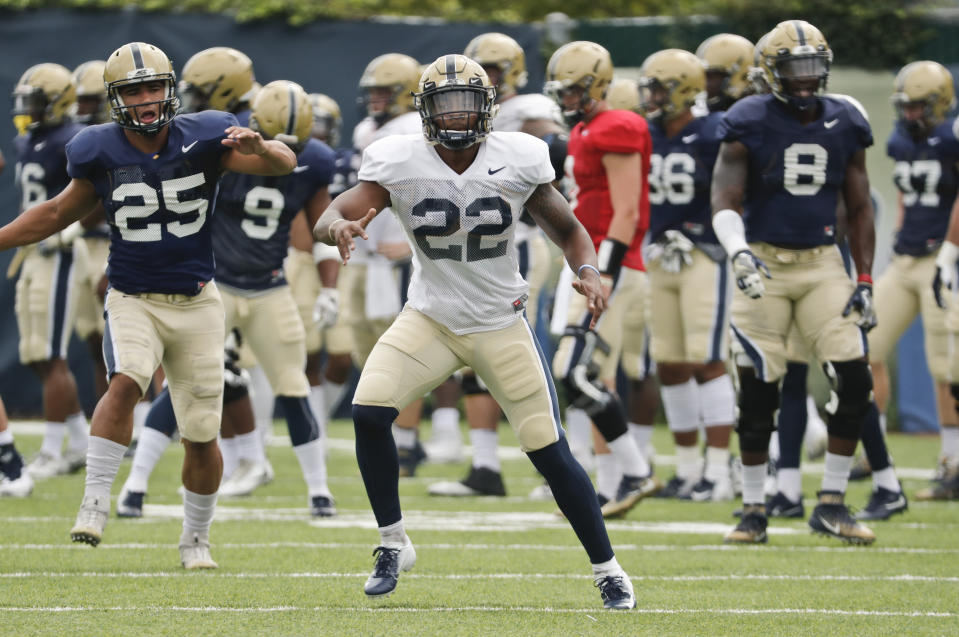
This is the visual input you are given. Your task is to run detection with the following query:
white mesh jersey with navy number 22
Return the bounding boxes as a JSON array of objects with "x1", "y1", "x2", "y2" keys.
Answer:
[{"x1": 359, "y1": 132, "x2": 556, "y2": 334}]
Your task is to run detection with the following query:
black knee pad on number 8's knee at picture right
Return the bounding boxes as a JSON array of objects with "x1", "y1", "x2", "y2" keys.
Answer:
[{"x1": 822, "y1": 360, "x2": 872, "y2": 440}]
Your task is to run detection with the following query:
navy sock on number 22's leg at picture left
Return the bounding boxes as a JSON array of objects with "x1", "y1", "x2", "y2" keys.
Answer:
[{"x1": 353, "y1": 405, "x2": 402, "y2": 527}]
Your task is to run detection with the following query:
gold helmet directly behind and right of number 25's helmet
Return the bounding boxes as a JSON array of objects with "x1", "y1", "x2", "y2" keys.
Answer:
[{"x1": 180, "y1": 46, "x2": 255, "y2": 113}]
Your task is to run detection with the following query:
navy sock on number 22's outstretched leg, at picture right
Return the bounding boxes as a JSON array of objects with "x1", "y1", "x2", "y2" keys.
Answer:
[{"x1": 526, "y1": 438, "x2": 613, "y2": 564}]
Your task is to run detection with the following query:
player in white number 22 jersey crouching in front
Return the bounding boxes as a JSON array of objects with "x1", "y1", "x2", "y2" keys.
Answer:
[{"x1": 314, "y1": 55, "x2": 636, "y2": 609}]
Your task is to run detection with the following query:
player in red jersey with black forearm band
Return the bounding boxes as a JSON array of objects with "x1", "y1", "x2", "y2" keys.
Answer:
[{"x1": 544, "y1": 41, "x2": 661, "y2": 516}]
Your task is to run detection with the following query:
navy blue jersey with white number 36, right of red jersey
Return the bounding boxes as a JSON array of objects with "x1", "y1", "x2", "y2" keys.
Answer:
[{"x1": 649, "y1": 113, "x2": 723, "y2": 246}]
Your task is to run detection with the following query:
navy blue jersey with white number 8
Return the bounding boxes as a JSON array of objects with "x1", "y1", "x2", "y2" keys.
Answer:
[{"x1": 720, "y1": 95, "x2": 872, "y2": 247}]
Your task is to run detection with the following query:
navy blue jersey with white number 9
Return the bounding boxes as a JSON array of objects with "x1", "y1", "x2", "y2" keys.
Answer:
[{"x1": 213, "y1": 139, "x2": 334, "y2": 290}]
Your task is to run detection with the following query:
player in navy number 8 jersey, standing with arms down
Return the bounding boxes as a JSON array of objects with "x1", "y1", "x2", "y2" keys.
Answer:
[{"x1": 711, "y1": 20, "x2": 876, "y2": 544}]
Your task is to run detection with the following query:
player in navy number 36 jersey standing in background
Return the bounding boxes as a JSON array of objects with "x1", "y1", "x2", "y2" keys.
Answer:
[{"x1": 640, "y1": 49, "x2": 736, "y2": 501}]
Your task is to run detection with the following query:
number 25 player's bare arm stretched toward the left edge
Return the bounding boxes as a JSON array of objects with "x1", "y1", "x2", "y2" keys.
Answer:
[{"x1": 0, "y1": 179, "x2": 99, "y2": 250}]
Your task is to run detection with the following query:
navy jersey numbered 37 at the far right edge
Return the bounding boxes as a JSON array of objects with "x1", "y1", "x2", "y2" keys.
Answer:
[{"x1": 886, "y1": 118, "x2": 959, "y2": 256}]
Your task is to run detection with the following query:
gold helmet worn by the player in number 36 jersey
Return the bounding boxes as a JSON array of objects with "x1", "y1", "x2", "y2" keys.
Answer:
[{"x1": 639, "y1": 49, "x2": 706, "y2": 121}]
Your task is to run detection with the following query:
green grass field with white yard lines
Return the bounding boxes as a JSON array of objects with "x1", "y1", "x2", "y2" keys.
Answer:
[{"x1": 0, "y1": 421, "x2": 959, "y2": 637}]
